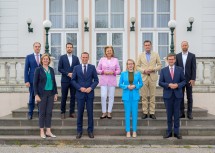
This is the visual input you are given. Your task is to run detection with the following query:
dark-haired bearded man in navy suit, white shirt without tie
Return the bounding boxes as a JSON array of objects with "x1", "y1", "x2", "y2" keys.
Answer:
[{"x1": 58, "y1": 43, "x2": 80, "y2": 119}]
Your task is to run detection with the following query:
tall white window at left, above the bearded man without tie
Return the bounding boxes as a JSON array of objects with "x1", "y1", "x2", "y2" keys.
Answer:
[{"x1": 48, "y1": 0, "x2": 80, "y2": 74}]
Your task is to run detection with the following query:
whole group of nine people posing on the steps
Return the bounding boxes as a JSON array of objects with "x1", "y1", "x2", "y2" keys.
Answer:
[{"x1": 24, "y1": 40, "x2": 196, "y2": 139}]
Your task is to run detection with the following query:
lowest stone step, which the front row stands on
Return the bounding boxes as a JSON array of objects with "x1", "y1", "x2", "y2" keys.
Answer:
[{"x1": 0, "y1": 135, "x2": 215, "y2": 147}]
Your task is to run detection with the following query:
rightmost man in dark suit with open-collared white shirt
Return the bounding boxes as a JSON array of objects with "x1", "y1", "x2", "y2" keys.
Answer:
[{"x1": 175, "y1": 41, "x2": 196, "y2": 119}]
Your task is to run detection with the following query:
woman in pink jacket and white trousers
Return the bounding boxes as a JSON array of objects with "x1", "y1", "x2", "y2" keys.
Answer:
[{"x1": 97, "y1": 46, "x2": 120, "y2": 119}]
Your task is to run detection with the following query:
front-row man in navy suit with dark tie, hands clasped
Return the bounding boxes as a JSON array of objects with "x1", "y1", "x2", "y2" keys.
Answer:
[{"x1": 71, "y1": 52, "x2": 99, "y2": 139}]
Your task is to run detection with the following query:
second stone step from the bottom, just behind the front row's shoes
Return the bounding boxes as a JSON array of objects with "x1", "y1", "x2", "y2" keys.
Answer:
[{"x1": 0, "y1": 126, "x2": 215, "y2": 138}]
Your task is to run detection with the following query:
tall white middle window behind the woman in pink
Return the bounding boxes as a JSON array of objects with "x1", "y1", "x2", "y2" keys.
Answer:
[{"x1": 95, "y1": 0, "x2": 126, "y2": 70}]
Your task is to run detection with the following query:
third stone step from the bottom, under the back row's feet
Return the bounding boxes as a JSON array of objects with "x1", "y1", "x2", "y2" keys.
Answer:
[{"x1": 0, "y1": 116, "x2": 215, "y2": 127}]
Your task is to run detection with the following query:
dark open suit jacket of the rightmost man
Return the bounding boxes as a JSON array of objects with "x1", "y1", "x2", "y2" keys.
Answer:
[{"x1": 175, "y1": 52, "x2": 196, "y2": 82}]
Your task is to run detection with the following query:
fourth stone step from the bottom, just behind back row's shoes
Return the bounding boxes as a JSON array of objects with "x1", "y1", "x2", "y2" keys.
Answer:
[{"x1": 12, "y1": 108, "x2": 208, "y2": 118}]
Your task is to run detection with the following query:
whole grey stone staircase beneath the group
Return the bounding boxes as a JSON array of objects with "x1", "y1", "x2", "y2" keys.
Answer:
[{"x1": 0, "y1": 89, "x2": 215, "y2": 145}]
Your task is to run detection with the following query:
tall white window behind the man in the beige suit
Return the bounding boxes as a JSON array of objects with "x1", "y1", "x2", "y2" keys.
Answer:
[{"x1": 140, "y1": 0, "x2": 171, "y2": 67}]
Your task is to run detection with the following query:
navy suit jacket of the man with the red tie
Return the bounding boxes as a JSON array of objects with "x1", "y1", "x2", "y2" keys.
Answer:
[{"x1": 159, "y1": 66, "x2": 186, "y2": 99}]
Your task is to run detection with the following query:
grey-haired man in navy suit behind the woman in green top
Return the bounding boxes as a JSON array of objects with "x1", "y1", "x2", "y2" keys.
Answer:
[{"x1": 24, "y1": 42, "x2": 41, "y2": 120}]
